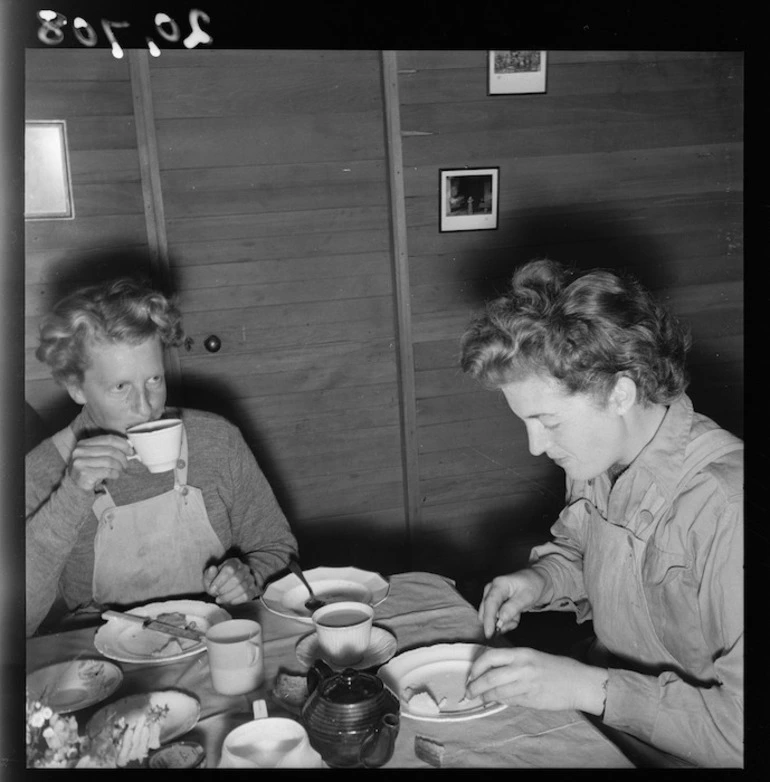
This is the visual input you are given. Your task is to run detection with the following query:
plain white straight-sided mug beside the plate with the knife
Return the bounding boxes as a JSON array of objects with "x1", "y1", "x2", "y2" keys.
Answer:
[{"x1": 206, "y1": 619, "x2": 264, "y2": 695}]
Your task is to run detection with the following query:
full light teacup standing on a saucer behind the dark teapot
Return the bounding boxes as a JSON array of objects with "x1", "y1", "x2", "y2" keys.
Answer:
[{"x1": 312, "y1": 601, "x2": 374, "y2": 666}]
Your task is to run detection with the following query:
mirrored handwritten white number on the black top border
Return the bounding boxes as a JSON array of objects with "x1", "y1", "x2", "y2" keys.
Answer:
[{"x1": 37, "y1": 8, "x2": 213, "y2": 59}]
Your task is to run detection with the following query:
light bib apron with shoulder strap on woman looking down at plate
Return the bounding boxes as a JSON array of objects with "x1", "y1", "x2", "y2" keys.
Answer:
[{"x1": 570, "y1": 429, "x2": 743, "y2": 679}]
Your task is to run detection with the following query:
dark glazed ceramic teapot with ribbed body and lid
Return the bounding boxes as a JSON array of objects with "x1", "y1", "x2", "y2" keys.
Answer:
[{"x1": 302, "y1": 660, "x2": 400, "y2": 768}]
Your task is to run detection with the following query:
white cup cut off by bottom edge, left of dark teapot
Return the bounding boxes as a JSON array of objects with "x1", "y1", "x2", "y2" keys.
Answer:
[{"x1": 219, "y1": 717, "x2": 321, "y2": 768}]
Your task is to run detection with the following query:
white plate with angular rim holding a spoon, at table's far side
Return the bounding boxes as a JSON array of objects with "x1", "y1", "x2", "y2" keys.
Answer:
[{"x1": 260, "y1": 567, "x2": 390, "y2": 624}]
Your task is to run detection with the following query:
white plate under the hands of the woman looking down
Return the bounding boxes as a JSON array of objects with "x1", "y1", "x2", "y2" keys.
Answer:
[{"x1": 377, "y1": 643, "x2": 506, "y2": 722}]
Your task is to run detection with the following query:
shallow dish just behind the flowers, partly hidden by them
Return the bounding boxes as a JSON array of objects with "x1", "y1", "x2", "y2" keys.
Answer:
[{"x1": 86, "y1": 690, "x2": 201, "y2": 744}]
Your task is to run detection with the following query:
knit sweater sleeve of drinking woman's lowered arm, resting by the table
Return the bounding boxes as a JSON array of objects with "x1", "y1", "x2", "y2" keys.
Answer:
[{"x1": 222, "y1": 428, "x2": 297, "y2": 590}]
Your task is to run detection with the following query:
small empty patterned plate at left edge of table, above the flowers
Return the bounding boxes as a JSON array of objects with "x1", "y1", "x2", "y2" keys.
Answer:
[{"x1": 27, "y1": 658, "x2": 123, "y2": 714}]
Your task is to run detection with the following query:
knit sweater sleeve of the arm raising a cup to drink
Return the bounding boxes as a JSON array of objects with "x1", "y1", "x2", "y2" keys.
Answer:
[{"x1": 25, "y1": 440, "x2": 94, "y2": 636}]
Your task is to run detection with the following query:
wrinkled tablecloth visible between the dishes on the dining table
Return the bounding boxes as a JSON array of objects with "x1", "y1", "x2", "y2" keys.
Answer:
[{"x1": 26, "y1": 572, "x2": 633, "y2": 769}]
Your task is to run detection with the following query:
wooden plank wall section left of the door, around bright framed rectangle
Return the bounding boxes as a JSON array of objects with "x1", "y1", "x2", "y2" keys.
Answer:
[{"x1": 24, "y1": 49, "x2": 149, "y2": 430}]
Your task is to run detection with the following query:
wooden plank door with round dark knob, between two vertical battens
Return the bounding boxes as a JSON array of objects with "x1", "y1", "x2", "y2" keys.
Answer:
[{"x1": 150, "y1": 51, "x2": 407, "y2": 571}]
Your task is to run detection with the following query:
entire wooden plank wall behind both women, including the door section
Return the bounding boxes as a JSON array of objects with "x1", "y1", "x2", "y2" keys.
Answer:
[{"x1": 26, "y1": 49, "x2": 743, "y2": 579}]
